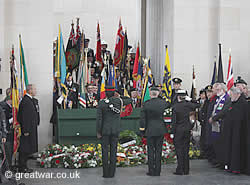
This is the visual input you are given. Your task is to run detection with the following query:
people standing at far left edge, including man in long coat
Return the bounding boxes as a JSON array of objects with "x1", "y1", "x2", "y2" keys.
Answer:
[{"x1": 0, "y1": 84, "x2": 40, "y2": 183}]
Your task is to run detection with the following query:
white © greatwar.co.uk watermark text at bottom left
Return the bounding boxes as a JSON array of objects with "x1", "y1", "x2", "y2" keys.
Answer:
[{"x1": 5, "y1": 171, "x2": 80, "y2": 180}]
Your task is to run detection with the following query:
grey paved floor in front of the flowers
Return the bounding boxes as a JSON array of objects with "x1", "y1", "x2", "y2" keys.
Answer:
[{"x1": 13, "y1": 160, "x2": 250, "y2": 185}]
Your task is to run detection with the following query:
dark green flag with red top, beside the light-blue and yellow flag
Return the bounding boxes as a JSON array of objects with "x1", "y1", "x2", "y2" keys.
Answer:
[{"x1": 65, "y1": 22, "x2": 79, "y2": 72}]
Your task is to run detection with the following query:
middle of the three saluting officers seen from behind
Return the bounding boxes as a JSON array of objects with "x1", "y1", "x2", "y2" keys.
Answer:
[{"x1": 140, "y1": 87, "x2": 170, "y2": 176}]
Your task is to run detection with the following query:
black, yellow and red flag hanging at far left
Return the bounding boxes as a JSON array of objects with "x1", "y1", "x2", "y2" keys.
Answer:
[{"x1": 10, "y1": 47, "x2": 21, "y2": 158}]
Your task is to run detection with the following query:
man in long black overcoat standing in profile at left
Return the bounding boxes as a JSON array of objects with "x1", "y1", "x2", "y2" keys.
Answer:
[{"x1": 17, "y1": 84, "x2": 39, "y2": 173}]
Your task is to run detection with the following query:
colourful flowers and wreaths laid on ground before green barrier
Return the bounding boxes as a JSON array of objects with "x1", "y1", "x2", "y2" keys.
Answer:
[{"x1": 38, "y1": 131, "x2": 176, "y2": 168}]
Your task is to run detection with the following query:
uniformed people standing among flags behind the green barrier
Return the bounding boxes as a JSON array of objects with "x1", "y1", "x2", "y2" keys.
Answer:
[{"x1": 54, "y1": 38, "x2": 143, "y2": 109}]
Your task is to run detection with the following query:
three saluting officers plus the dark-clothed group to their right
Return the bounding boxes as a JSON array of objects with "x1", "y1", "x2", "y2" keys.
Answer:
[{"x1": 97, "y1": 77, "x2": 250, "y2": 178}]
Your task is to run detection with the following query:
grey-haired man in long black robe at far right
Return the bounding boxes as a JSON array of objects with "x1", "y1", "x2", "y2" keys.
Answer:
[{"x1": 212, "y1": 87, "x2": 249, "y2": 174}]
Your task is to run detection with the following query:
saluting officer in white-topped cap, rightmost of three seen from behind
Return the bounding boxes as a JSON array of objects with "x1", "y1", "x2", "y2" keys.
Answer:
[{"x1": 172, "y1": 90, "x2": 200, "y2": 175}]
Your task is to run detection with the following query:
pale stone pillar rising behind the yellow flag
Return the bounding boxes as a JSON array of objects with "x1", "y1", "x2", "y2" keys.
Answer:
[{"x1": 146, "y1": 0, "x2": 173, "y2": 84}]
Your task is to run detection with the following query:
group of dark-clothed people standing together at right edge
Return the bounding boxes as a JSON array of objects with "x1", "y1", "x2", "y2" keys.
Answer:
[{"x1": 196, "y1": 77, "x2": 250, "y2": 174}]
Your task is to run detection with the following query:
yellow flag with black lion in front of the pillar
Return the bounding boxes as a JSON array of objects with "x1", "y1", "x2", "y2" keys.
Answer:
[{"x1": 162, "y1": 46, "x2": 172, "y2": 103}]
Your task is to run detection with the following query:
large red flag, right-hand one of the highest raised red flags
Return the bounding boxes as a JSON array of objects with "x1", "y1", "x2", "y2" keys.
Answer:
[{"x1": 114, "y1": 19, "x2": 124, "y2": 66}]
